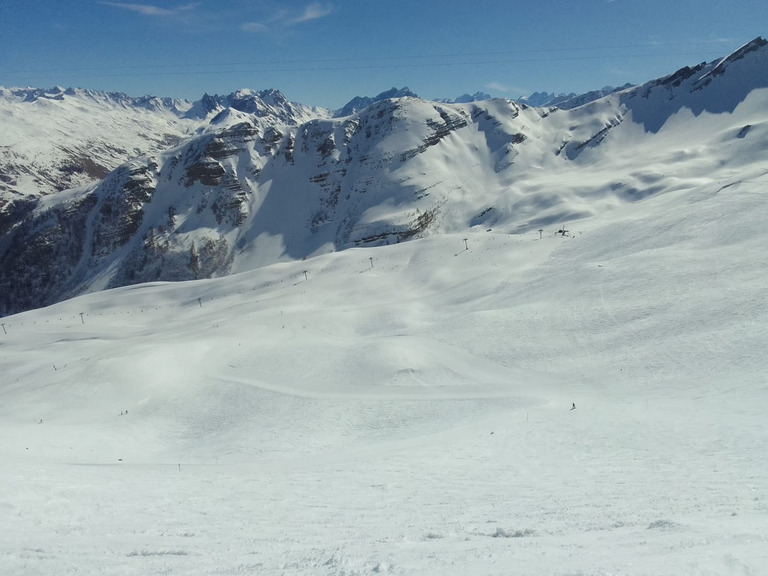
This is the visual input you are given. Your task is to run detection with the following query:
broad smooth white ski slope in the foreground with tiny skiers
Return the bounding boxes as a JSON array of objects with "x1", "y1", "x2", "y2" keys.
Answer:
[{"x1": 0, "y1": 172, "x2": 768, "y2": 576}]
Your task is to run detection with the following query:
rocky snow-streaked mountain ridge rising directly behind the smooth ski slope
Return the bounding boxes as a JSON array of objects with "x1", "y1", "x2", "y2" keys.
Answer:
[{"x1": 0, "y1": 40, "x2": 768, "y2": 315}]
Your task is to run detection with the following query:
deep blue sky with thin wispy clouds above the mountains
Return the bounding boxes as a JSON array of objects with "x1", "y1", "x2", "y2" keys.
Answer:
[{"x1": 0, "y1": 0, "x2": 768, "y2": 108}]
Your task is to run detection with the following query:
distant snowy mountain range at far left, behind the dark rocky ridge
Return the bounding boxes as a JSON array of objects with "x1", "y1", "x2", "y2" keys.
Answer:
[{"x1": 0, "y1": 87, "x2": 330, "y2": 201}]
